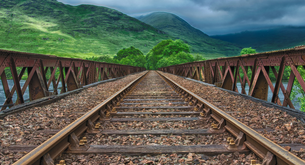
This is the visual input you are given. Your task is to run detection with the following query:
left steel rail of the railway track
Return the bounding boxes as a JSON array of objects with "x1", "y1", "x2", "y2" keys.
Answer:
[{"x1": 14, "y1": 72, "x2": 148, "y2": 165}]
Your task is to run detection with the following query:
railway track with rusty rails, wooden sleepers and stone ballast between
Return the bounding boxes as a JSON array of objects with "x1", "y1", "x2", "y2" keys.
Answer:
[{"x1": 11, "y1": 71, "x2": 305, "y2": 165}]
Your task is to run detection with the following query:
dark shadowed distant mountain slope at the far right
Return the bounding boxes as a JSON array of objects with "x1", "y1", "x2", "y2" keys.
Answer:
[{"x1": 212, "y1": 26, "x2": 305, "y2": 52}]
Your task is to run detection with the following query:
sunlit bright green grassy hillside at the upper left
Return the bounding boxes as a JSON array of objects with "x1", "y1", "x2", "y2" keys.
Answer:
[{"x1": 0, "y1": 0, "x2": 173, "y2": 58}]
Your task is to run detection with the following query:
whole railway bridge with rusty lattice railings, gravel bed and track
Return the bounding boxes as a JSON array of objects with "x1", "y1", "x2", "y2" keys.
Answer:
[{"x1": 0, "y1": 47, "x2": 305, "y2": 165}]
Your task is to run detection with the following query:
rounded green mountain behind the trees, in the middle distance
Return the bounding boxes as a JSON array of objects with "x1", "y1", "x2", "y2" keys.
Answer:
[{"x1": 137, "y1": 12, "x2": 241, "y2": 56}]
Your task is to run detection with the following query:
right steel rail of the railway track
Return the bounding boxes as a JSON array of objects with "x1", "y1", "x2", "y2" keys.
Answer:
[{"x1": 158, "y1": 71, "x2": 305, "y2": 165}]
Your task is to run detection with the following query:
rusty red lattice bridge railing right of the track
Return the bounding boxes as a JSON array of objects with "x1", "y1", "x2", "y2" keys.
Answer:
[{"x1": 159, "y1": 46, "x2": 305, "y2": 109}]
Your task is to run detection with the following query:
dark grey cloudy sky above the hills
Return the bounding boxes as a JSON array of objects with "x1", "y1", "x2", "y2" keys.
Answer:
[{"x1": 58, "y1": 0, "x2": 305, "y2": 35}]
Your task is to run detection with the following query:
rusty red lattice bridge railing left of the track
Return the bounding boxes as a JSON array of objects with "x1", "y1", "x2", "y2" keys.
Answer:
[{"x1": 0, "y1": 50, "x2": 145, "y2": 111}]
